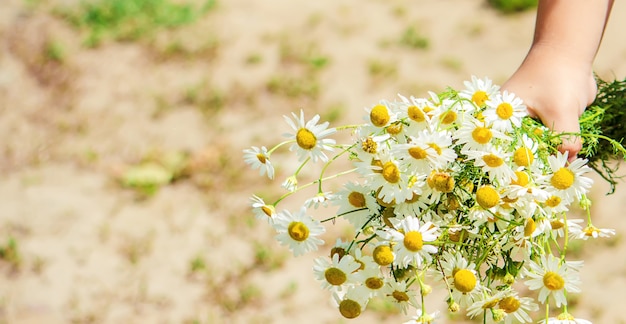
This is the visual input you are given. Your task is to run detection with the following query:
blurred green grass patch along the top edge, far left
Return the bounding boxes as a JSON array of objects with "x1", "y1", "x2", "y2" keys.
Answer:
[{"x1": 56, "y1": 0, "x2": 216, "y2": 47}]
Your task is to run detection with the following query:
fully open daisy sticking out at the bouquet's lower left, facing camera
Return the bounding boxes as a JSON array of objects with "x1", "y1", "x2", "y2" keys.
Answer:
[{"x1": 274, "y1": 207, "x2": 326, "y2": 256}]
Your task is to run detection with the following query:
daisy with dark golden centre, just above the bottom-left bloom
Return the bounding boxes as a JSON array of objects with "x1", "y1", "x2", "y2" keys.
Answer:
[{"x1": 313, "y1": 254, "x2": 361, "y2": 290}]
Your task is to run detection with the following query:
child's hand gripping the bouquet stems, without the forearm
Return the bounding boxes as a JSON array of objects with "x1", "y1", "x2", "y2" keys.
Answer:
[{"x1": 502, "y1": 46, "x2": 597, "y2": 161}]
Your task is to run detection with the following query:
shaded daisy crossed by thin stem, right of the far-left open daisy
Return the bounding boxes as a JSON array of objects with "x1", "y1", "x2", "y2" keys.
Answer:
[{"x1": 333, "y1": 182, "x2": 379, "y2": 229}]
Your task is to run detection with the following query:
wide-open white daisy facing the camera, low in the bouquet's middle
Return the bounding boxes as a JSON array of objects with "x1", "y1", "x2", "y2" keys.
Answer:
[{"x1": 378, "y1": 216, "x2": 438, "y2": 268}]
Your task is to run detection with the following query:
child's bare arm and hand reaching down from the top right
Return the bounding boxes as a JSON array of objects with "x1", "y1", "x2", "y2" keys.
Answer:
[{"x1": 503, "y1": 0, "x2": 613, "y2": 160}]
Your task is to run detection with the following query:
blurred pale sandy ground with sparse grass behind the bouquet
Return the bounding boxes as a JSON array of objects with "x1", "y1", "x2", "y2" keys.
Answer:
[{"x1": 0, "y1": 0, "x2": 626, "y2": 324}]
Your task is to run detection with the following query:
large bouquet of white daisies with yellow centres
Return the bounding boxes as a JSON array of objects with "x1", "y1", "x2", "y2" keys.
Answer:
[{"x1": 244, "y1": 77, "x2": 624, "y2": 323}]
